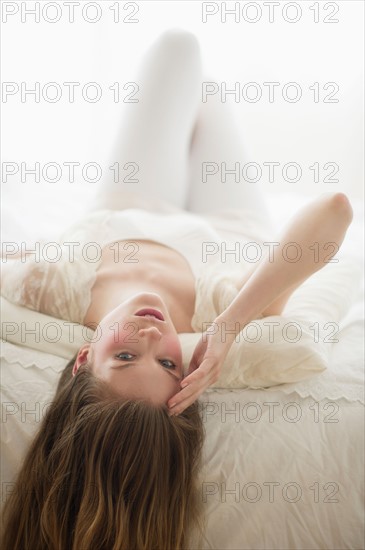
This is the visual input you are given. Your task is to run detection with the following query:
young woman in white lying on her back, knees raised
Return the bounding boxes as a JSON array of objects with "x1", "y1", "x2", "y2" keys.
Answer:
[{"x1": 2, "y1": 31, "x2": 352, "y2": 550}]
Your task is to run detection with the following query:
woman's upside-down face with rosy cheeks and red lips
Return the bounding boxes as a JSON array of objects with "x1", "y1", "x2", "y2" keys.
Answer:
[{"x1": 73, "y1": 292, "x2": 183, "y2": 404}]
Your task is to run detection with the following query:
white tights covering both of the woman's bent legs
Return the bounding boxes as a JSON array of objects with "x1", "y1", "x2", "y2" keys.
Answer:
[{"x1": 93, "y1": 30, "x2": 268, "y2": 229}]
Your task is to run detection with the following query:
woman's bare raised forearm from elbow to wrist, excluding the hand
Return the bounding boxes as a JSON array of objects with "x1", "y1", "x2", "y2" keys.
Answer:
[{"x1": 216, "y1": 193, "x2": 353, "y2": 342}]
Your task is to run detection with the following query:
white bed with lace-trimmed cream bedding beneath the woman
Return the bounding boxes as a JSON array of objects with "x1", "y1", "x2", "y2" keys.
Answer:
[{"x1": 1, "y1": 195, "x2": 364, "y2": 550}]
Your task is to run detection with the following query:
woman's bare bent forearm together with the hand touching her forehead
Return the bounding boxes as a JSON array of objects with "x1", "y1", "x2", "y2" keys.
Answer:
[{"x1": 169, "y1": 193, "x2": 352, "y2": 414}]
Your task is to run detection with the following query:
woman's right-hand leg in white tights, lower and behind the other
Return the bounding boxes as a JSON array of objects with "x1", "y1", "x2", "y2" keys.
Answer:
[{"x1": 188, "y1": 84, "x2": 271, "y2": 234}]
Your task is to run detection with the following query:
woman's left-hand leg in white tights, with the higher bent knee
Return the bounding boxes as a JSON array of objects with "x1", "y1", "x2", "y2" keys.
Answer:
[{"x1": 89, "y1": 30, "x2": 202, "y2": 211}]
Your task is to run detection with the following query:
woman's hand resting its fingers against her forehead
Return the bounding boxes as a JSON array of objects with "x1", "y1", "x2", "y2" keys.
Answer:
[{"x1": 168, "y1": 322, "x2": 234, "y2": 415}]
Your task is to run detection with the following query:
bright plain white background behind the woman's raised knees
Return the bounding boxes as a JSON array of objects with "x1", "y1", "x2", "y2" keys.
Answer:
[{"x1": 1, "y1": 0, "x2": 364, "y2": 242}]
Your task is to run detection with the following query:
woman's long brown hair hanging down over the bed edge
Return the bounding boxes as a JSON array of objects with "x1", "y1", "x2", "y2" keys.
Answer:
[{"x1": 2, "y1": 359, "x2": 204, "y2": 550}]
